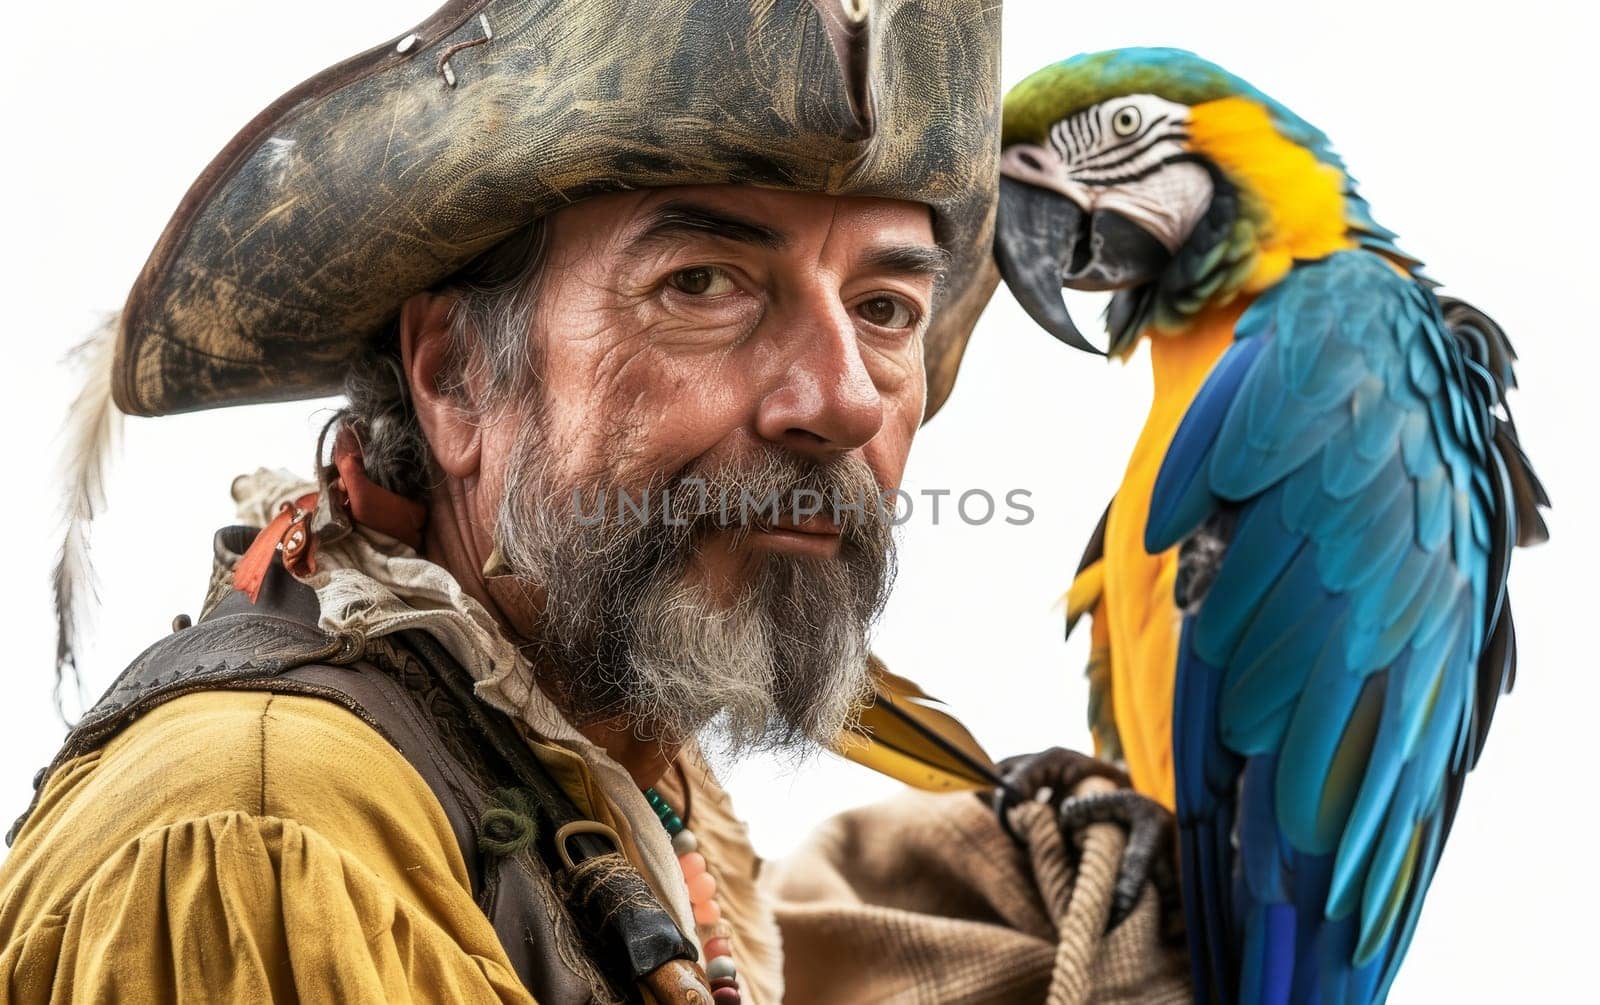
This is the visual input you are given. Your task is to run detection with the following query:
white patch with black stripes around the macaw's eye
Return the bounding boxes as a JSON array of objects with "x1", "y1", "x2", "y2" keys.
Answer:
[{"x1": 1000, "y1": 94, "x2": 1213, "y2": 251}]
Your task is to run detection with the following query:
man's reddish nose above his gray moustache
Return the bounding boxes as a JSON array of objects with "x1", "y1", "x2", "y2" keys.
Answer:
[{"x1": 755, "y1": 299, "x2": 883, "y2": 456}]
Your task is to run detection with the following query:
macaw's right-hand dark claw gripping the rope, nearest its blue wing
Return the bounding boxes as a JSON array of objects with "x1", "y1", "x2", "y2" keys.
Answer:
[{"x1": 1059, "y1": 789, "x2": 1182, "y2": 931}]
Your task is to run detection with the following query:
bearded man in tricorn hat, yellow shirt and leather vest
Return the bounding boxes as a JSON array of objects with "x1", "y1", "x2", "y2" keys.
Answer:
[{"x1": 0, "y1": 0, "x2": 1181, "y2": 1003}]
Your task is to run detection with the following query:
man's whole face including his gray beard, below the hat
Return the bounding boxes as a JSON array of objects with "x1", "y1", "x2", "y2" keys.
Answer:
[{"x1": 467, "y1": 186, "x2": 944, "y2": 746}]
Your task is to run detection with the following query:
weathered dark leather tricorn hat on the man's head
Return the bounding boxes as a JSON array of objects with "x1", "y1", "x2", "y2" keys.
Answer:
[{"x1": 112, "y1": 0, "x2": 1000, "y2": 416}]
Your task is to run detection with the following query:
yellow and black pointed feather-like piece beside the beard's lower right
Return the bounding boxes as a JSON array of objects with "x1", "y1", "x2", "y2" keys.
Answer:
[{"x1": 834, "y1": 656, "x2": 1003, "y2": 792}]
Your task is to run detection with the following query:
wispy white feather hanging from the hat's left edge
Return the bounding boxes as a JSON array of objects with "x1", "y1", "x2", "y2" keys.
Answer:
[{"x1": 53, "y1": 314, "x2": 122, "y2": 719}]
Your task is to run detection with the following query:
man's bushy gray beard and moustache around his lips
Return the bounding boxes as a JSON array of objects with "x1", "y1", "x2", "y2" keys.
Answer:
[{"x1": 498, "y1": 437, "x2": 894, "y2": 757}]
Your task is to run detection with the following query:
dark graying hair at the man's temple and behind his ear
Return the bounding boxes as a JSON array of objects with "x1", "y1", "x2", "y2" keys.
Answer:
[{"x1": 328, "y1": 219, "x2": 549, "y2": 499}]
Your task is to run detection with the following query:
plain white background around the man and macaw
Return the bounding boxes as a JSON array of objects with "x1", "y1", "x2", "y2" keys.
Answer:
[{"x1": 0, "y1": 0, "x2": 1600, "y2": 1002}]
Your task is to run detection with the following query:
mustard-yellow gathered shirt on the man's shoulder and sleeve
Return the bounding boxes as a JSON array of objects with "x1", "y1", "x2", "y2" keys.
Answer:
[{"x1": 0, "y1": 691, "x2": 533, "y2": 1002}]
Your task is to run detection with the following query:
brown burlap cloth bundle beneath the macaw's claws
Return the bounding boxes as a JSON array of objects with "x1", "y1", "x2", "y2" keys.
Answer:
[{"x1": 763, "y1": 779, "x2": 1190, "y2": 1005}]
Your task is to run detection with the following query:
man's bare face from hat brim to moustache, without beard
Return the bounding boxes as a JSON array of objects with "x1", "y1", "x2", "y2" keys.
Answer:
[{"x1": 485, "y1": 186, "x2": 944, "y2": 550}]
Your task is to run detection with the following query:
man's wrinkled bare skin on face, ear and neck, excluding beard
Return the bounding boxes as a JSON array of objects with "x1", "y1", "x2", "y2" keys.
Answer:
[{"x1": 400, "y1": 186, "x2": 944, "y2": 784}]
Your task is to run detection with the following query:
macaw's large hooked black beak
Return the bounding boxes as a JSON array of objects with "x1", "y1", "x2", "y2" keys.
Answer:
[{"x1": 995, "y1": 168, "x2": 1171, "y2": 355}]
